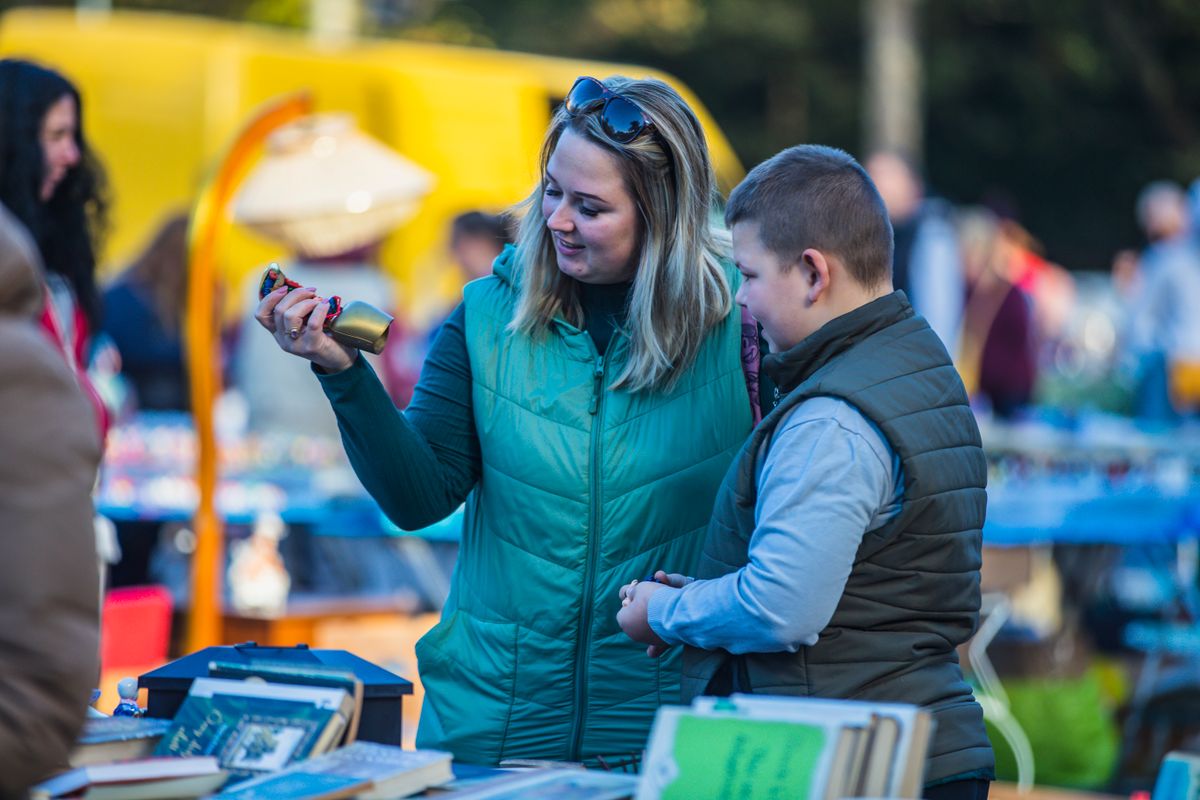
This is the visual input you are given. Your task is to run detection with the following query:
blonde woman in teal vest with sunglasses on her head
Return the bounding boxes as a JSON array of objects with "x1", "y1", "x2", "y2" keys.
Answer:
[{"x1": 256, "y1": 78, "x2": 751, "y2": 764}]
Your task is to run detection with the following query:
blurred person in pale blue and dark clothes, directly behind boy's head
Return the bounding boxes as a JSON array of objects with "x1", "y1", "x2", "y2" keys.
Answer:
[{"x1": 863, "y1": 151, "x2": 965, "y2": 355}]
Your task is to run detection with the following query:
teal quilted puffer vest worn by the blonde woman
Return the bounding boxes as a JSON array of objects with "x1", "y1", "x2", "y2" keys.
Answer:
[{"x1": 416, "y1": 249, "x2": 751, "y2": 764}]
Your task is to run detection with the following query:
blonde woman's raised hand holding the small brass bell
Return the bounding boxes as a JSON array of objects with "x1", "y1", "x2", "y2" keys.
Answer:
[{"x1": 254, "y1": 287, "x2": 358, "y2": 373}]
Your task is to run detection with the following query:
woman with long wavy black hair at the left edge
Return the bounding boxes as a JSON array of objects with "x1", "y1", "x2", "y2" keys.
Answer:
[{"x1": 0, "y1": 59, "x2": 108, "y2": 433}]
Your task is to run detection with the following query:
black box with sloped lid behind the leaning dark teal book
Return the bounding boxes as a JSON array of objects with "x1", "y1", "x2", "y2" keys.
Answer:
[{"x1": 138, "y1": 642, "x2": 413, "y2": 747}]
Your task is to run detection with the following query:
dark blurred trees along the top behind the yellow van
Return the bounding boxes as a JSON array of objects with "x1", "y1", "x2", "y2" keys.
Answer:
[{"x1": 9, "y1": 0, "x2": 1200, "y2": 269}]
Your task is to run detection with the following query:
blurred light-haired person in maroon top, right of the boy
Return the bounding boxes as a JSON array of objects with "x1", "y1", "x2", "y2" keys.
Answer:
[{"x1": 958, "y1": 209, "x2": 1037, "y2": 419}]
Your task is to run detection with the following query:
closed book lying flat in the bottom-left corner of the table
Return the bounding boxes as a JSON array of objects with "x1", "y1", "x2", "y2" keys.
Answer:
[{"x1": 30, "y1": 756, "x2": 227, "y2": 800}]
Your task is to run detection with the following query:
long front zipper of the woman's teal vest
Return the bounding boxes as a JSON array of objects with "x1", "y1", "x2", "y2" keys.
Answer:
[{"x1": 570, "y1": 355, "x2": 605, "y2": 762}]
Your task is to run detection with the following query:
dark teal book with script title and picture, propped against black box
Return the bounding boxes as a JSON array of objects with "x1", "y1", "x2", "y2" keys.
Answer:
[{"x1": 155, "y1": 678, "x2": 354, "y2": 780}]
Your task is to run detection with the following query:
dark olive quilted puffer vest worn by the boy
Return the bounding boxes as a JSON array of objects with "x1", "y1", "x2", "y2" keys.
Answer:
[{"x1": 683, "y1": 291, "x2": 994, "y2": 783}]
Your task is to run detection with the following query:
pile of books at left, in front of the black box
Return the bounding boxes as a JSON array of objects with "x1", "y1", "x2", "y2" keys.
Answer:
[{"x1": 31, "y1": 662, "x2": 454, "y2": 800}]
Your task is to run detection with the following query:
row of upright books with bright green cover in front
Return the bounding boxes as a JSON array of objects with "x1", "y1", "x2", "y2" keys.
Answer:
[{"x1": 637, "y1": 694, "x2": 934, "y2": 800}]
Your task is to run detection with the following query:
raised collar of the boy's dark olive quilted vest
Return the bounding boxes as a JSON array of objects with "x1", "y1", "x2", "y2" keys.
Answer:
[{"x1": 762, "y1": 291, "x2": 913, "y2": 393}]
